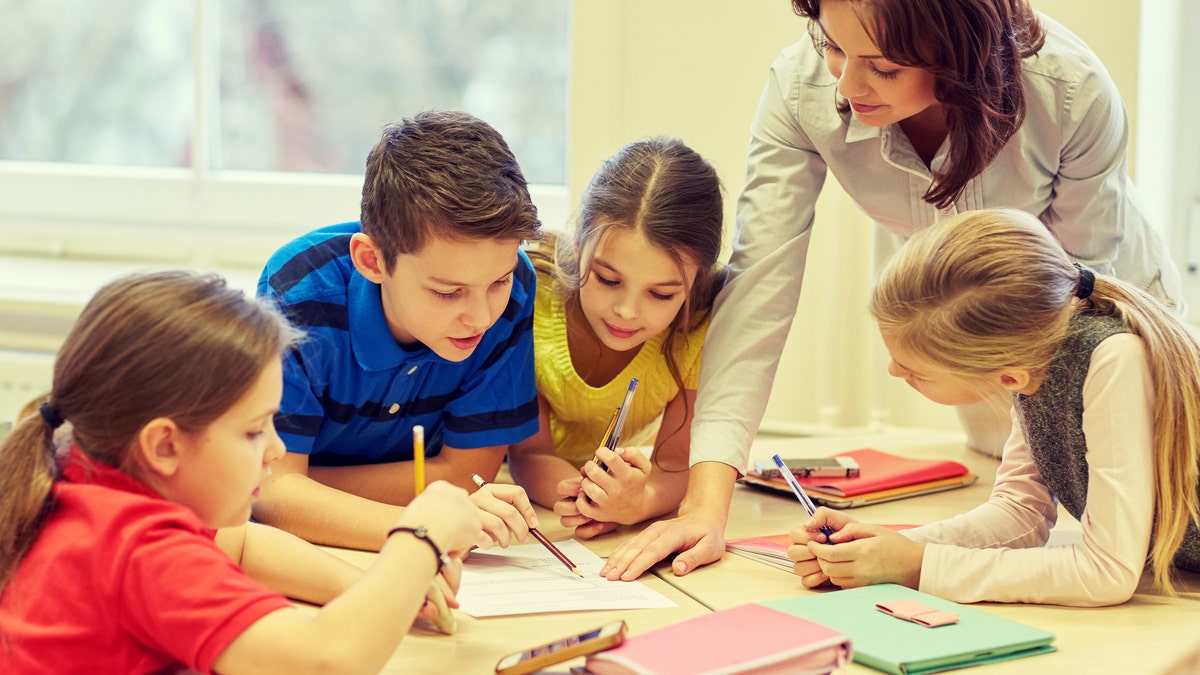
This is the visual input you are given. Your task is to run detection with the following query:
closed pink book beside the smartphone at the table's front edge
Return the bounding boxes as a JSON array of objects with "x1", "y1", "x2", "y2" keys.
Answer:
[{"x1": 587, "y1": 604, "x2": 851, "y2": 675}]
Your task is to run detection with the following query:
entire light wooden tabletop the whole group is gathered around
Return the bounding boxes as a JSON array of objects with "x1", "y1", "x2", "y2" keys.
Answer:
[{"x1": 324, "y1": 431, "x2": 1200, "y2": 675}]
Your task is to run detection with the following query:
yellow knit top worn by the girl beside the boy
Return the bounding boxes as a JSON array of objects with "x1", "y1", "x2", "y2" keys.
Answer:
[{"x1": 533, "y1": 274, "x2": 708, "y2": 467}]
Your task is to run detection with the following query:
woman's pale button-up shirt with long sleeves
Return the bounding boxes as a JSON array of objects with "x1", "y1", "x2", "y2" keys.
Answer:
[{"x1": 691, "y1": 16, "x2": 1182, "y2": 471}]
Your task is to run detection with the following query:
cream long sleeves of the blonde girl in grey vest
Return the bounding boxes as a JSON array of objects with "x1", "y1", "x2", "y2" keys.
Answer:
[{"x1": 904, "y1": 333, "x2": 1154, "y2": 607}]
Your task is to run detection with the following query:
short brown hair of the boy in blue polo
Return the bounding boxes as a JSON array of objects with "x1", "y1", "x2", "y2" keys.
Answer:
[{"x1": 360, "y1": 112, "x2": 541, "y2": 273}]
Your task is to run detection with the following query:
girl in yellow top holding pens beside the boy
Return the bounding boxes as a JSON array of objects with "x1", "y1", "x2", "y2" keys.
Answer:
[{"x1": 509, "y1": 137, "x2": 722, "y2": 538}]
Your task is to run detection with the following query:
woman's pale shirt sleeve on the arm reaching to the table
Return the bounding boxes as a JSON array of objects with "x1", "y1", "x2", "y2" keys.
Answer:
[{"x1": 691, "y1": 47, "x2": 834, "y2": 471}]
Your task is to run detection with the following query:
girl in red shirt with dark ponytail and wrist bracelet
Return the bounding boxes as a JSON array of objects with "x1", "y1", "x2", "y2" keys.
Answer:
[{"x1": 0, "y1": 271, "x2": 486, "y2": 673}]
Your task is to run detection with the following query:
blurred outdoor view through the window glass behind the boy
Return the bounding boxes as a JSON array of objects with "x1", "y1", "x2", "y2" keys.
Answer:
[{"x1": 0, "y1": 0, "x2": 570, "y2": 184}]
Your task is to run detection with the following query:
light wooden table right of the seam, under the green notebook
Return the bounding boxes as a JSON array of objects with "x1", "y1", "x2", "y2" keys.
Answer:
[{"x1": 656, "y1": 432, "x2": 1200, "y2": 675}]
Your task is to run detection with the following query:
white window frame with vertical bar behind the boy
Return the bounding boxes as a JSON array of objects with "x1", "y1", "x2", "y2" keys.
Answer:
[{"x1": 0, "y1": 0, "x2": 569, "y2": 269}]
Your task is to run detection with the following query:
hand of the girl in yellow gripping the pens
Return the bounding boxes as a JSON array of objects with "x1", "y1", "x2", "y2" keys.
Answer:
[{"x1": 575, "y1": 448, "x2": 652, "y2": 525}]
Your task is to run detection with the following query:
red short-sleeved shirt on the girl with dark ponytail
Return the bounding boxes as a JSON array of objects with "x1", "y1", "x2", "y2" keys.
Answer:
[{"x1": 0, "y1": 448, "x2": 289, "y2": 674}]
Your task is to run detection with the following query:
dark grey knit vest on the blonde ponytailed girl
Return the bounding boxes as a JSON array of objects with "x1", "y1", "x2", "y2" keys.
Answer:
[{"x1": 1013, "y1": 312, "x2": 1200, "y2": 572}]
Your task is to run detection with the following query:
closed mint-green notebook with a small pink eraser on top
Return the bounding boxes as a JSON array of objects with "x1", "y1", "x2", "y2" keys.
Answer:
[{"x1": 761, "y1": 584, "x2": 1055, "y2": 675}]
